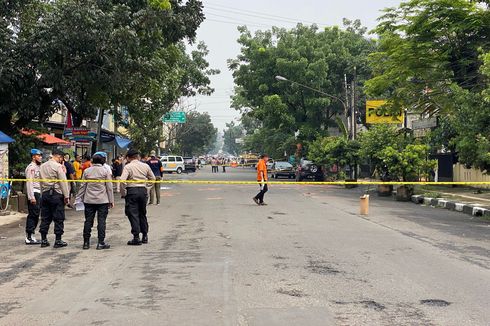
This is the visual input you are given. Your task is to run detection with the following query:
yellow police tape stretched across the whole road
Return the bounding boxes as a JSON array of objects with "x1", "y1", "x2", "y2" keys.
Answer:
[{"x1": 0, "y1": 178, "x2": 490, "y2": 186}]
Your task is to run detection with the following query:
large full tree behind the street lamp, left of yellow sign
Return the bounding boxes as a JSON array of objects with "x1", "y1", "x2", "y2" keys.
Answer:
[{"x1": 229, "y1": 20, "x2": 375, "y2": 156}]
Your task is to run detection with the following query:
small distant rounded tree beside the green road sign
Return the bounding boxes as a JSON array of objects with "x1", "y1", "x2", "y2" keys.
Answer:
[{"x1": 175, "y1": 111, "x2": 218, "y2": 156}]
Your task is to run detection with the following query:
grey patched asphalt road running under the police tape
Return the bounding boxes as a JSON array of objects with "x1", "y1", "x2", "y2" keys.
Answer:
[{"x1": 0, "y1": 168, "x2": 490, "y2": 326}]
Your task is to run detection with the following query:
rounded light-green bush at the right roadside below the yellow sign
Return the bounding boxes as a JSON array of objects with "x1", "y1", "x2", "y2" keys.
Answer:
[{"x1": 380, "y1": 144, "x2": 437, "y2": 181}]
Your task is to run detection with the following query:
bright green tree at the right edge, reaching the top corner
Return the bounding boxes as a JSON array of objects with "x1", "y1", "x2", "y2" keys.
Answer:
[{"x1": 366, "y1": 0, "x2": 490, "y2": 170}]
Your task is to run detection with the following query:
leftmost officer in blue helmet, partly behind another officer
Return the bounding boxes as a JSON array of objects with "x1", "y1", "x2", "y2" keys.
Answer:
[{"x1": 25, "y1": 148, "x2": 43, "y2": 245}]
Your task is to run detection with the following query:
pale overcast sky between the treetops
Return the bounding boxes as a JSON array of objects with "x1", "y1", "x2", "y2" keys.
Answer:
[{"x1": 187, "y1": 0, "x2": 401, "y2": 132}]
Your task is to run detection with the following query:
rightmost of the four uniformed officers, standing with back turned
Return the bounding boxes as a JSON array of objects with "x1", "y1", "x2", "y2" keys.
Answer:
[{"x1": 121, "y1": 149, "x2": 155, "y2": 246}]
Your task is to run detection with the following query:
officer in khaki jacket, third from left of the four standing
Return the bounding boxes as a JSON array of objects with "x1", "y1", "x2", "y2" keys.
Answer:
[{"x1": 77, "y1": 153, "x2": 114, "y2": 250}]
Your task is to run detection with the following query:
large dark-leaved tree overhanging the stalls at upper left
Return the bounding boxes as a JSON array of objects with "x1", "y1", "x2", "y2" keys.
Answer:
[{"x1": 0, "y1": 0, "x2": 217, "y2": 172}]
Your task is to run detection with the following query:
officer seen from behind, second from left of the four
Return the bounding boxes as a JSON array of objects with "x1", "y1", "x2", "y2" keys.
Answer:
[{"x1": 39, "y1": 150, "x2": 70, "y2": 248}]
